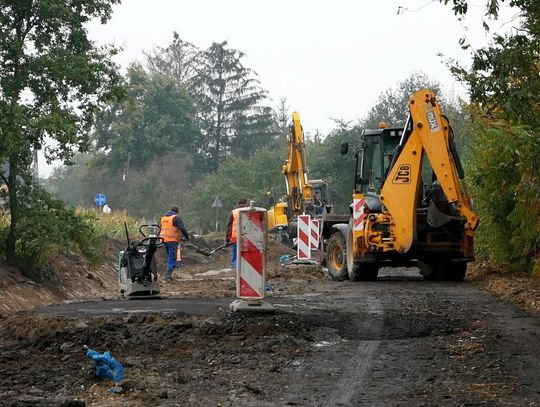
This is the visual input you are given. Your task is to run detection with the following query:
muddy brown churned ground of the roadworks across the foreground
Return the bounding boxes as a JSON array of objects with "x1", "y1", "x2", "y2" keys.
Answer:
[{"x1": 0, "y1": 242, "x2": 540, "y2": 406}]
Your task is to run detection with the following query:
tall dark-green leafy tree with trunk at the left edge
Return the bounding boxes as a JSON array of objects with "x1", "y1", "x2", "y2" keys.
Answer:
[{"x1": 0, "y1": 0, "x2": 119, "y2": 265}]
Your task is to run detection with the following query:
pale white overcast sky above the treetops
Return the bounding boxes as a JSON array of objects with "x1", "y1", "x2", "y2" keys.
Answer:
[{"x1": 40, "y1": 0, "x2": 516, "y2": 175}]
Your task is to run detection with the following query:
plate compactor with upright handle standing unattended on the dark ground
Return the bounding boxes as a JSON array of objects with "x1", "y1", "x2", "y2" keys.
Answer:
[{"x1": 118, "y1": 223, "x2": 163, "y2": 298}]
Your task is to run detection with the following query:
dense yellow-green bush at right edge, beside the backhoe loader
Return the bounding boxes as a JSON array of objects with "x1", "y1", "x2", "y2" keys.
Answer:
[{"x1": 465, "y1": 116, "x2": 540, "y2": 270}]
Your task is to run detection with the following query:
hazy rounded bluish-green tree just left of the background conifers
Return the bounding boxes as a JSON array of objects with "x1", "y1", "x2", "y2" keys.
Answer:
[{"x1": 95, "y1": 64, "x2": 198, "y2": 170}]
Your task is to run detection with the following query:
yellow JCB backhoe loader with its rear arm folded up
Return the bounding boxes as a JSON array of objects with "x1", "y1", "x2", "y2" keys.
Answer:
[{"x1": 323, "y1": 90, "x2": 478, "y2": 281}]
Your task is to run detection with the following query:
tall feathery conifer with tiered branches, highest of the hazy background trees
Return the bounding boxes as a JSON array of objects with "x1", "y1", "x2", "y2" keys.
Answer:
[{"x1": 192, "y1": 41, "x2": 275, "y2": 169}]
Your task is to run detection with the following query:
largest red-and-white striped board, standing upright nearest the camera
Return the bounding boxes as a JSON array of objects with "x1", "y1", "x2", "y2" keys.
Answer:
[{"x1": 236, "y1": 208, "x2": 267, "y2": 300}]
